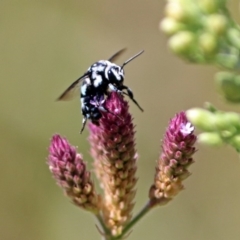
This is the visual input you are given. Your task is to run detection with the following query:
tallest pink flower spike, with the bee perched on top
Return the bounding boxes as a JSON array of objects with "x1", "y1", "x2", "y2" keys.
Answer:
[{"x1": 89, "y1": 92, "x2": 137, "y2": 236}]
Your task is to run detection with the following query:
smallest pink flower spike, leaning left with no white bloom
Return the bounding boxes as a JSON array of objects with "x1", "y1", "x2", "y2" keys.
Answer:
[{"x1": 48, "y1": 134, "x2": 101, "y2": 213}]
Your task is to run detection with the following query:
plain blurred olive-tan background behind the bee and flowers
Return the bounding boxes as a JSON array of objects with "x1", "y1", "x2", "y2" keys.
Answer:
[{"x1": 0, "y1": 0, "x2": 240, "y2": 240}]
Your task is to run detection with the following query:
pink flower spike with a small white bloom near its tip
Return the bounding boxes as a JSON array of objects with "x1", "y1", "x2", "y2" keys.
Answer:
[{"x1": 149, "y1": 112, "x2": 197, "y2": 206}]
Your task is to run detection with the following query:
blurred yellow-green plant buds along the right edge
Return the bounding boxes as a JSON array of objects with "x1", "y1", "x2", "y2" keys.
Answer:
[{"x1": 161, "y1": 0, "x2": 240, "y2": 152}]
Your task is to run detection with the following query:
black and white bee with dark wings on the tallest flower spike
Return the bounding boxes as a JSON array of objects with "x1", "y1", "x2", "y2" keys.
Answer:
[{"x1": 57, "y1": 49, "x2": 143, "y2": 133}]
